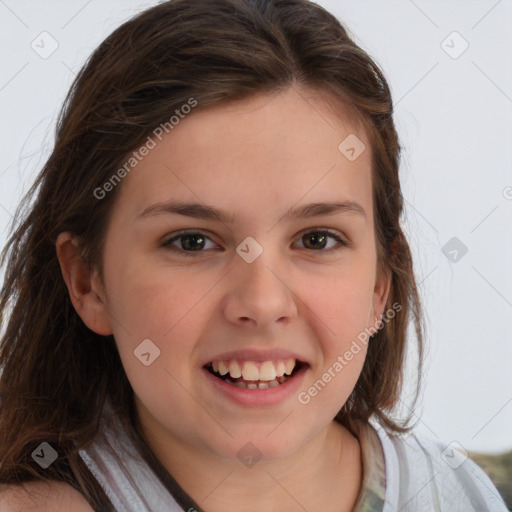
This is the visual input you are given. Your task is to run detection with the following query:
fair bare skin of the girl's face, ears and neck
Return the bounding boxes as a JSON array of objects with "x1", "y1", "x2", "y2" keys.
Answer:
[{"x1": 57, "y1": 87, "x2": 390, "y2": 512}]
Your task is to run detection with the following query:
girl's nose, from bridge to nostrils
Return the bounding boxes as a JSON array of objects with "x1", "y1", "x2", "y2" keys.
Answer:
[{"x1": 225, "y1": 249, "x2": 297, "y2": 329}]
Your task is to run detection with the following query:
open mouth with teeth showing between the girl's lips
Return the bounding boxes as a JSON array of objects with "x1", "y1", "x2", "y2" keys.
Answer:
[{"x1": 203, "y1": 359, "x2": 309, "y2": 390}]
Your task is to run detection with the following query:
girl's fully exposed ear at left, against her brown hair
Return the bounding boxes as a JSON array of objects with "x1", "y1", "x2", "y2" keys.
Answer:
[{"x1": 55, "y1": 232, "x2": 112, "y2": 336}]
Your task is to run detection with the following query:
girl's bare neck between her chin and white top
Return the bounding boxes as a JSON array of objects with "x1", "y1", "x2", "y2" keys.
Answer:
[{"x1": 132, "y1": 402, "x2": 363, "y2": 512}]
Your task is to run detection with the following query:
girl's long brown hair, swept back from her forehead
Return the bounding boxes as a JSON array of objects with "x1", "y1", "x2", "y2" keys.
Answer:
[{"x1": 0, "y1": 0, "x2": 423, "y2": 508}]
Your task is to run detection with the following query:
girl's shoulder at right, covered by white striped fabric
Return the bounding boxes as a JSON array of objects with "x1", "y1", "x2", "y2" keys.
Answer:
[{"x1": 379, "y1": 424, "x2": 508, "y2": 512}]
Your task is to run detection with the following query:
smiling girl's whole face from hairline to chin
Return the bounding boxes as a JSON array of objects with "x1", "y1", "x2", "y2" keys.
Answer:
[{"x1": 92, "y1": 89, "x2": 386, "y2": 460}]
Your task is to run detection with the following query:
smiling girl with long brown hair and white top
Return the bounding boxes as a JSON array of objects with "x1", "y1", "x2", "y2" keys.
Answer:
[{"x1": 0, "y1": 0, "x2": 506, "y2": 512}]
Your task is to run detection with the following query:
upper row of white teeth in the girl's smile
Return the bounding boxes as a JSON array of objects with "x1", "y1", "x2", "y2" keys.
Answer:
[{"x1": 212, "y1": 358, "x2": 297, "y2": 381}]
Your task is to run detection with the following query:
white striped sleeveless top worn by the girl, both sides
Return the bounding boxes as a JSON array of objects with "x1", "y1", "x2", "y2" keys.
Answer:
[{"x1": 79, "y1": 404, "x2": 508, "y2": 512}]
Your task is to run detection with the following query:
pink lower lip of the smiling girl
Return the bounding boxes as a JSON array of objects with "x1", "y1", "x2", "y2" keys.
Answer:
[{"x1": 201, "y1": 365, "x2": 308, "y2": 407}]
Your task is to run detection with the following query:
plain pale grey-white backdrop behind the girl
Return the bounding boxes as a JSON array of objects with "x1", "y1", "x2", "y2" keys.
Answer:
[{"x1": 0, "y1": 0, "x2": 512, "y2": 452}]
